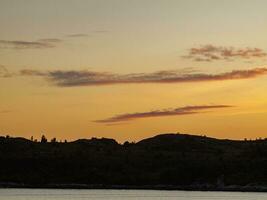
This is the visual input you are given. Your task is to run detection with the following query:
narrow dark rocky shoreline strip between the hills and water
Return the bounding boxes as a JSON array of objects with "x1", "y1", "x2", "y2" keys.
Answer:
[{"x1": 0, "y1": 183, "x2": 267, "y2": 192}]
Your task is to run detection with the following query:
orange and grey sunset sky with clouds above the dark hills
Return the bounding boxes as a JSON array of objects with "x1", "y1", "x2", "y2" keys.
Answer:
[{"x1": 0, "y1": 0, "x2": 267, "y2": 142}]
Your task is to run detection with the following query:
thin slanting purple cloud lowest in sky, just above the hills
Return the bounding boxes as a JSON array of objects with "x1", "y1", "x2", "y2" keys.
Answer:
[{"x1": 94, "y1": 105, "x2": 233, "y2": 123}]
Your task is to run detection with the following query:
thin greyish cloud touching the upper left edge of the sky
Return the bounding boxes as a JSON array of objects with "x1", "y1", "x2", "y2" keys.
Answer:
[{"x1": 0, "y1": 38, "x2": 62, "y2": 49}]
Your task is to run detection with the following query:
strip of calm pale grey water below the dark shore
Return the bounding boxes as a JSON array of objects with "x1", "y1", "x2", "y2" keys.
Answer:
[{"x1": 0, "y1": 189, "x2": 267, "y2": 200}]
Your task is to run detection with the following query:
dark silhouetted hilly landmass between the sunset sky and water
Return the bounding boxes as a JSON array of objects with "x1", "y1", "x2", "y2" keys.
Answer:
[{"x1": 0, "y1": 134, "x2": 267, "y2": 192}]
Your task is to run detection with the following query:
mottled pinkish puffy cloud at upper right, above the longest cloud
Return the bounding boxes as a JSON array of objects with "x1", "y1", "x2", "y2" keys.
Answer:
[{"x1": 183, "y1": 45, "x2": 267, "y2": 62}]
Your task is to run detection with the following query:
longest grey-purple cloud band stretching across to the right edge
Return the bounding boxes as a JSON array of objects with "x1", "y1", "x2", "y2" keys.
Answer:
[{"x1": 20, "y1": 68, "x2": 267, "y2": 87}]
